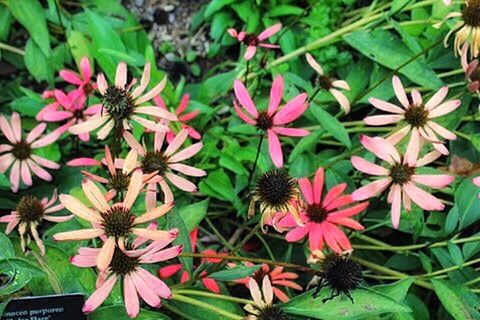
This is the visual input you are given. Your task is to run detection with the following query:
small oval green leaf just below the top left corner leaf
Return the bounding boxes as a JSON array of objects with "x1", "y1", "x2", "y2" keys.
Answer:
[{"x1": 24, "y1": 38, "x2": 53, "y2": 83}]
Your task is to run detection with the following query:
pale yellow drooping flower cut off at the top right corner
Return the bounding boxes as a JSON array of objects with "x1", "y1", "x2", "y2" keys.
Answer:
[{"x1": 434, "y1": 0, "x2": 480, "y2": 58}]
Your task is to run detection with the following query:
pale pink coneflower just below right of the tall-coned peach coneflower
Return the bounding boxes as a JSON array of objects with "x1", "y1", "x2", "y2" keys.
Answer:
[{"x1": 125, "y1": 129, "x2": 207, "y2": 210}]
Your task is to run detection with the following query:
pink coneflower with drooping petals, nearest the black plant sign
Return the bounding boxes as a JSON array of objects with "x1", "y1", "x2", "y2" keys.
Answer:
[{"x1": 70, "y1": 237, "x2": 182, "y2": 318}]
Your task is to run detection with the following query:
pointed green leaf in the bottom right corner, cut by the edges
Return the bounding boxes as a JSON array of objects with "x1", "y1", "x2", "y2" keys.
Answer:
[{"x1": 432, "y1": 279, "x2": 480, "y2": 320}]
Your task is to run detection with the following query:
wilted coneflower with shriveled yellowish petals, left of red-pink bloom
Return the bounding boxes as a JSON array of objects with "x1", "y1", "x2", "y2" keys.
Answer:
[{"x1": 248, "y1": 169, "x2": 299, "y2": 228}]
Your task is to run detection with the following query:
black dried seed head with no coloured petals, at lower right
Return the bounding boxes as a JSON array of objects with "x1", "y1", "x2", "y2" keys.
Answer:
[{"x1": 313, "y1": 253, "x2": 362, "y2": 303}]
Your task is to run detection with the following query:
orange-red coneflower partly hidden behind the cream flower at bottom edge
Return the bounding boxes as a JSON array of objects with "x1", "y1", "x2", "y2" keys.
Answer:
[{"x1": 228, "y1": 261, "x2": 303, "y2": 302}]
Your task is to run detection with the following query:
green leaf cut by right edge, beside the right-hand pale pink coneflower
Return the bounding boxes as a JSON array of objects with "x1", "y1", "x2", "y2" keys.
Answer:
[{"x1": 455, "y1": 179, "x2": 480, "y2": 229}]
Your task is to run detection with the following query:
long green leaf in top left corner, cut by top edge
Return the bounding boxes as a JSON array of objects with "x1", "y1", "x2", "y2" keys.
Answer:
[{"x1": 8, "y1": 0, "x2": 50, "y2": 57}]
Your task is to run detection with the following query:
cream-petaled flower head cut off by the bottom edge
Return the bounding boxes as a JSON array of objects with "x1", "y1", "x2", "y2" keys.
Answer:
[{"x1": 244, "y1": 276, "x2": 290, "y2": 320}]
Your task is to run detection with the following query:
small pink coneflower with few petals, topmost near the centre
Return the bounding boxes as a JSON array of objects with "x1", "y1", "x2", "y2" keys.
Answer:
[{"x1": 227, "y1": 23, "x2": 282, "y2": 61}]
